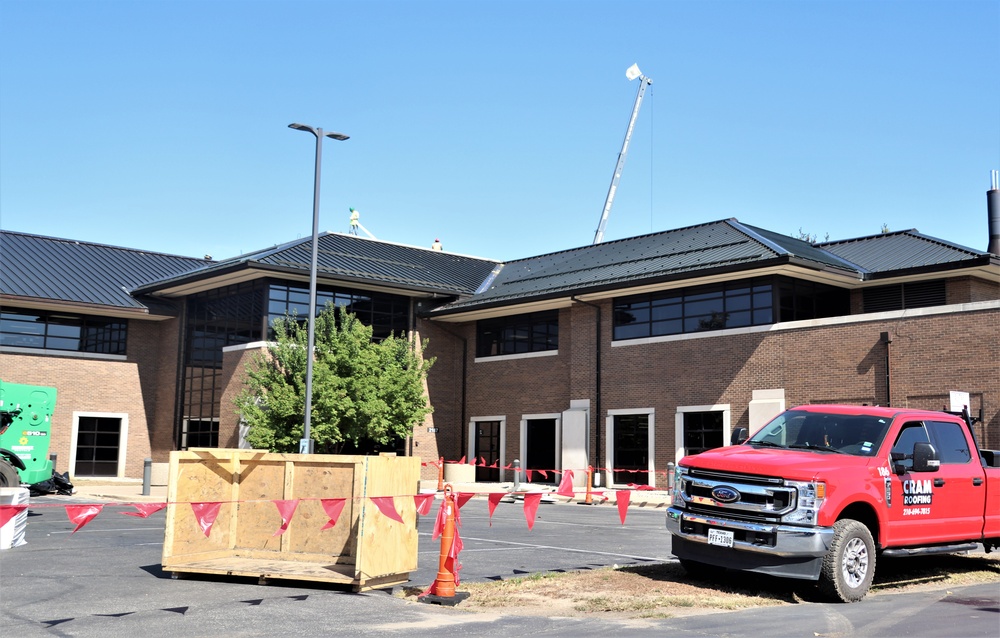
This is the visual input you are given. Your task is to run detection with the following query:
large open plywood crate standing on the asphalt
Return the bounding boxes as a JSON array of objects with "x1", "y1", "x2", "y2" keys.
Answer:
[{"x1": 162, "y1": 448, "x2": 420, "y2": 591}]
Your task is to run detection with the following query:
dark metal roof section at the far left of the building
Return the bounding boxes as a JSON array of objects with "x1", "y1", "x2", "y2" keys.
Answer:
[{"x1": 0, "y1": 231, "x2": 206, "y2": 310}]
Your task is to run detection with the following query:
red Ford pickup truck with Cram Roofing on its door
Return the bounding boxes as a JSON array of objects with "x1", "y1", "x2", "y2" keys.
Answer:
[{"x1": 667, "y1": 405, "x2": 1000, "y2": 602}]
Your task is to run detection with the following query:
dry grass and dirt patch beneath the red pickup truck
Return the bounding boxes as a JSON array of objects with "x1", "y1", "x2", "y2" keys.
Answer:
[{"x1": 402, "y1": 554, "x2": 1000, "y2": 619}]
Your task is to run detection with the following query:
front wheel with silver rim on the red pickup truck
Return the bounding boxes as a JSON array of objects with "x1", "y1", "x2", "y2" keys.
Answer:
[{"x1": 819, "y1": 518, "x2": 875, "y2": 603}]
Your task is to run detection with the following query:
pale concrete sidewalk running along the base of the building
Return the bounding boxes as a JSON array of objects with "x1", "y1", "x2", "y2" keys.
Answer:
[{"x1": 60, "y1": 479, "x2": 670, "y2": 508}]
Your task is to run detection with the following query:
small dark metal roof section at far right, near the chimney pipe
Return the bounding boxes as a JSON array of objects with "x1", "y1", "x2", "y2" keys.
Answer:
[{"x1": 818, "y1": 230, "x2": 986, "y2": 273}]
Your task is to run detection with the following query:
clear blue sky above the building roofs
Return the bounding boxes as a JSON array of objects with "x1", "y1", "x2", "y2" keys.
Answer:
[{"x1": 0, "y1": 0, "x2": 1000, "y2": 260}]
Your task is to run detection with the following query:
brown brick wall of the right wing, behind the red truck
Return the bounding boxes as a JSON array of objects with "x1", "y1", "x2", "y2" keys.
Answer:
[{"x1": 446, "y1": 302, "x2": 1000, "y2": 483}]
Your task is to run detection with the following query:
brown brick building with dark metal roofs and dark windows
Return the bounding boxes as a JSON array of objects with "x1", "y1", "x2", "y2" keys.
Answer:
[{"x1": 0, "y1": 219, "x2": 1000, "y2": 485}]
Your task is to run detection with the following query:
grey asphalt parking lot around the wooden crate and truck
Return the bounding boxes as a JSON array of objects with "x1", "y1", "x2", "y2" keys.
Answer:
[{"x1": 0, "y1": 496, "x2": 1000, "y2": 638}]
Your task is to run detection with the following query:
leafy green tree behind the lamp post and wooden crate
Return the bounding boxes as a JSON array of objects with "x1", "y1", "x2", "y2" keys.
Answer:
[{"x1": 235, "y1": 306, "x2": 434, "y2": 454}]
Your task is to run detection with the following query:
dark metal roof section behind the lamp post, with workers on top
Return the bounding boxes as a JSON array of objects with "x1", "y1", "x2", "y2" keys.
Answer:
[{"x1": 138, "y1": 233, "x2": 497, "y2": 296}]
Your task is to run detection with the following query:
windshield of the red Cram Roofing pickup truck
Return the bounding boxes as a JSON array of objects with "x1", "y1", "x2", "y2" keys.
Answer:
[{"x1": 747, "y1": 410, "x2": 889, "y2": 456}]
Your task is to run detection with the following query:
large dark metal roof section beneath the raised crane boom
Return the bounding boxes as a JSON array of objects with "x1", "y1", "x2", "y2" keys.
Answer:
[{"x1": 431, "y1": 219, "x2": 859, "y2": 314}]
